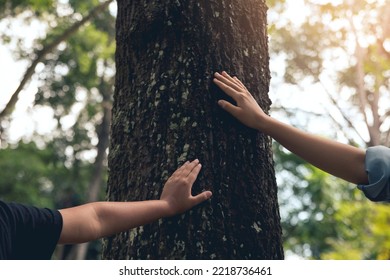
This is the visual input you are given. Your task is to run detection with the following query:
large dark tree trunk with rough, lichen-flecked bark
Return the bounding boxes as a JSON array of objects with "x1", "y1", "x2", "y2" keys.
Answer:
[{"x1": 103, "y1": 0, "x2": 283, "y2": 259}]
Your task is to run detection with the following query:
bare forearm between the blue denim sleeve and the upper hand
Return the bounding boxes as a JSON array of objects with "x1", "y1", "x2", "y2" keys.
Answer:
[{"x1": 258, "y1": 116, "x2": 368, "y2": 184}]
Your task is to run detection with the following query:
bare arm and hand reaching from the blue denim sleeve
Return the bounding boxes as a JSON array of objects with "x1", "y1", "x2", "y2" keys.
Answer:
[{"x1": 214, "y1": 72, "x2": 368, "y2": 184}]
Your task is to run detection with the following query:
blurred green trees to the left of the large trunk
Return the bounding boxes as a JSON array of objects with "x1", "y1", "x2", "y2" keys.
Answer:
[{"x1": 0, "y1": 0, "x2": 115, "y2": 259}]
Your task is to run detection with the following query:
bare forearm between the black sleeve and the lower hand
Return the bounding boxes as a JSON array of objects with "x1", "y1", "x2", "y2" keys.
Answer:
[{"x1": 59, "y1": 200, "x2": 171, "y2": 244}]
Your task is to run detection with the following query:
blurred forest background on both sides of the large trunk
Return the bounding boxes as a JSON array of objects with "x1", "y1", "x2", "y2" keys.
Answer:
[{"x1": 0, "y1": 0, "x2": 390, "y2": 259}]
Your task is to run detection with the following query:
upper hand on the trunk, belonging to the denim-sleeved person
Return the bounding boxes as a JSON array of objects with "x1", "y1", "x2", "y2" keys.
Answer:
[{"x1": 214, "y1": 71, "x2": 267, "y2": 130}]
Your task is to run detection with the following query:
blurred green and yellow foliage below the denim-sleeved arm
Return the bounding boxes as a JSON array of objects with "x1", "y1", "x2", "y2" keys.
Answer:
[{"x1": 274, "y1": 144, "x2": 390, "y2": 260}]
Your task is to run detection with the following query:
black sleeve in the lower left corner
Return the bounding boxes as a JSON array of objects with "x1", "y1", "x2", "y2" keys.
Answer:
[{"x1": 0, "y1": 201, "x2": 62, "y2": 260}]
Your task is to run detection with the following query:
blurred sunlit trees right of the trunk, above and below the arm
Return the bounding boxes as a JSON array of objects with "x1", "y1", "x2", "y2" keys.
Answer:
[{"x1": 269, "y1": 0, "x2": 390, "y2": 259}]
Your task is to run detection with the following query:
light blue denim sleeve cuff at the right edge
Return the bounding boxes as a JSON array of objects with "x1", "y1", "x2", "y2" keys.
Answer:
[{"x1": 358, "y1": 146, "x2": 390, "y2": 202}]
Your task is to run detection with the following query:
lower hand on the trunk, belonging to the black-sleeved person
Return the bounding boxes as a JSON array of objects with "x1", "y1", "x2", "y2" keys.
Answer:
[{"x1": 160, "y1": 160, "x2": 212, "y2": 216}]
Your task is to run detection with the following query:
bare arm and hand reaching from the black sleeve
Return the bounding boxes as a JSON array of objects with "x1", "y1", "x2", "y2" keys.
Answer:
[{"x1": 59, "y1": 160, "x2": 211, "y2": 243}]
